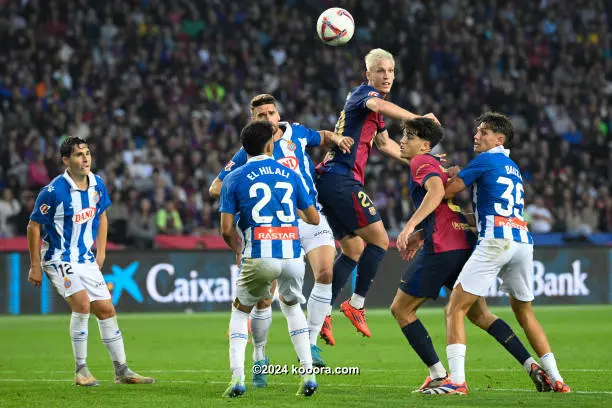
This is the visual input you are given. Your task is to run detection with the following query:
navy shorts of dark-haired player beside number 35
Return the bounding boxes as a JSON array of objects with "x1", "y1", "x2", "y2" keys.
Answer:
[{"x1": 400, "y1": 249, "x2": 472, "y2": 299}]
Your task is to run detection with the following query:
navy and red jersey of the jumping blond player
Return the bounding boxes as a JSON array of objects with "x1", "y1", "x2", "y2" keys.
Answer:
[{"x1": 316, "y1": 84, "x2": 385, "y2": 184}]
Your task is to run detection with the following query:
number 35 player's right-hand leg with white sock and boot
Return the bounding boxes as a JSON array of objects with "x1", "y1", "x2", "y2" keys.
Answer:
[{"x1": 510, "y1": 296, "x2": 571, "y2": 393}]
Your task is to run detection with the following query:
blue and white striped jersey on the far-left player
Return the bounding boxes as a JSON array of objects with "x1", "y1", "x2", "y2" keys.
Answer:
[{"x1": 30, "y1": 172, "x2": 111, "y2": 264}]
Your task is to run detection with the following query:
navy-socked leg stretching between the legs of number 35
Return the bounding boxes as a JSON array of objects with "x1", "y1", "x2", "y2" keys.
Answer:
[{"x1": 467, "y1": 297, "x2": 552, "y2": 392}]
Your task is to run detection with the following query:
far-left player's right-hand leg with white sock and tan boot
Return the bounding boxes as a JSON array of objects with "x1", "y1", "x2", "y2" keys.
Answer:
[{"x1": 91, "y1": 299, "x2": 155, "y2": 384}]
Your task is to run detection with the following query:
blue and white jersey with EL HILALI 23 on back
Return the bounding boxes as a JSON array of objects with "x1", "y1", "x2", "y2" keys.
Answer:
[{"x1": 220, "y1": 155, "x2": 314, "y2": 259}]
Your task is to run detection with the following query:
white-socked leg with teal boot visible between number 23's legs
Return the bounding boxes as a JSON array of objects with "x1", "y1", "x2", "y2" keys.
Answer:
[{"x1": 251, "y1": 296, "x2": 276, "y2": 388}]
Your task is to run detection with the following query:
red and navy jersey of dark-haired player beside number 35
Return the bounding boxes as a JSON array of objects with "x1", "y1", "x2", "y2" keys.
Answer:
[{"x1": 410, "y1": 154, "x2": 476, "y2": 253}]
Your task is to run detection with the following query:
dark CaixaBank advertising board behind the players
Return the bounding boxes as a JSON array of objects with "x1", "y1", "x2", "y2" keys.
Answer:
[{"x1": 0, "y1": 247, "x2": 612, "y2": 314}]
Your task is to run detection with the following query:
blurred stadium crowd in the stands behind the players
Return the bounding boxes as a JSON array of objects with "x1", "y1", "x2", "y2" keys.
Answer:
[{"x1": 0, "y1": 0, "x2": 612, "y2": 247}]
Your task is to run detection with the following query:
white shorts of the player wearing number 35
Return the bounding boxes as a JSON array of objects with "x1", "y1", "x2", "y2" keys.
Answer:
[{"x1": 455, "y1": 238, "x2": 534, "y2": 302}]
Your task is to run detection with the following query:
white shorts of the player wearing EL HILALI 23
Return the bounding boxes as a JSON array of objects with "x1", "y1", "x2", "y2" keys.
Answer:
[{"x1": 236, "y1": 258, "x2": 306, "y2": 306}]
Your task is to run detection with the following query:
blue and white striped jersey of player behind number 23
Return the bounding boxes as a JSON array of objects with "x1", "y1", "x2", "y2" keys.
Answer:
[{"x1": 217, "y1": 122, "x2": 321, "y2": 210}]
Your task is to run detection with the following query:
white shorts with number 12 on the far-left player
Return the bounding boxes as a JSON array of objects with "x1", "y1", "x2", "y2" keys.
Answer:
[{"x1": 42, "y1": 262, "x2": 111, "y2": 302}]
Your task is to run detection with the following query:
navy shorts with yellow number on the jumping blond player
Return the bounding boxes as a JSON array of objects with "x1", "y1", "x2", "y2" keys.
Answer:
[{"x1": 317, "y1": 173, "x2": 381, "y2": 240}]
